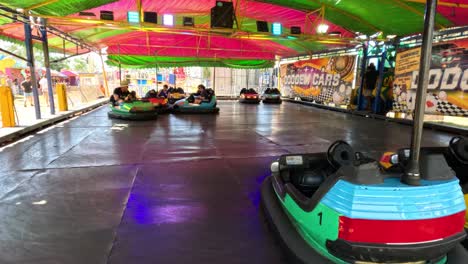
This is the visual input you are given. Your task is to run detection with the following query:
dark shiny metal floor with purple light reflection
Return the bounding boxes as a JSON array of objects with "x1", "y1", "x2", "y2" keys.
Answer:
[{"x1": 0, "y1": 102, "x2": 456, "y2": 264}]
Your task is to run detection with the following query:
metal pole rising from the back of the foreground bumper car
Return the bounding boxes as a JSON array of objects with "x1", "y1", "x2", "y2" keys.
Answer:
[{"x1": 401, "y1": 0, "x2": 437, "y2": 186}]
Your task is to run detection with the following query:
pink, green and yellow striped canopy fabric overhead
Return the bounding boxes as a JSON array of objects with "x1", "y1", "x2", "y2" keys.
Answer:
[{"x1": 0, "y1": 0, "x2": 468, "y2": 68}]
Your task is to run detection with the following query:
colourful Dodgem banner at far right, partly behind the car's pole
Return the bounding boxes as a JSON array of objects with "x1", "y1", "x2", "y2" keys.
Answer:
[{"x1": 393, "y1": 39, "x2": 468, "y2": 117}]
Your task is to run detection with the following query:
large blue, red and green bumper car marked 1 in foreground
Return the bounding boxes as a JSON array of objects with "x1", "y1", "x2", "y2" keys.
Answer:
[{"x1": 261, "y1": 141, "x2": 468, "y2": 264}]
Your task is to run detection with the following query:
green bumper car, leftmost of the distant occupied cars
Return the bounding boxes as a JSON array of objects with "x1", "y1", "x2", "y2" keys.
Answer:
[{"x1": 107, "y1": 101, "x2": 158, "y2": 121}]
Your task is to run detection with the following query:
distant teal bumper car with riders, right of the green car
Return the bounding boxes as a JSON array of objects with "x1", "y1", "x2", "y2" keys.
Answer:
[{"x1": 172, "y1": 89, "x2": 219, "y2": 114}]
